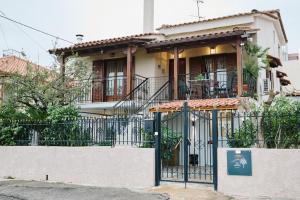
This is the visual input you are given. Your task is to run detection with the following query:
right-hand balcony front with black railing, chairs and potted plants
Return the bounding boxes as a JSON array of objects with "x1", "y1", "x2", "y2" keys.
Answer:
[{"x1": 177, "y1": 69, "x2": 256, "y2": 100}]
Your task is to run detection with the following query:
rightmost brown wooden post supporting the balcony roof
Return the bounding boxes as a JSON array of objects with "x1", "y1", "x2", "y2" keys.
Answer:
[{"x1": 236, "y1": 38, "x2": 243, "y2": 97}]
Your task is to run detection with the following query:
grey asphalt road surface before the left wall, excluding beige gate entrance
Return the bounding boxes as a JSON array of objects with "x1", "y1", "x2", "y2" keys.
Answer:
[{"x1": 0, "y1": 180, "x2": 169, "y2": 200}]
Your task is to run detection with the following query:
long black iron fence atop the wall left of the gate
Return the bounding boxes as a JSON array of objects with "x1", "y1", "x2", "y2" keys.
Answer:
[{"x1": 0, "y1": 117, "x2": 153, "y2": 147}]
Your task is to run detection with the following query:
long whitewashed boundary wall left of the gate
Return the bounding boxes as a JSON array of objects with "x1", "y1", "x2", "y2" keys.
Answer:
[{"x1": 0, "y1": 146, "x2": 155, "y2": 188}]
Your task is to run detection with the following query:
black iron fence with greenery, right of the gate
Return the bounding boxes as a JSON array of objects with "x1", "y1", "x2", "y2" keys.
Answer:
[{"x1": 218, "y1": 111, "x2": 300, "y2": 149}]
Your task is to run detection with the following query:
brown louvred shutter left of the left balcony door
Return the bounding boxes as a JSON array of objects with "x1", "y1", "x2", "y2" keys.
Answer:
[{"x1": 92, "y1": 60, "x2": 105, "y2": 102}]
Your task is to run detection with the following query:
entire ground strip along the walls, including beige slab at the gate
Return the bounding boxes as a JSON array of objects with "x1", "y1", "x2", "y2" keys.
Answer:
[{"x1": 0, "y1": 179, "x2": 286, "y2": 200}]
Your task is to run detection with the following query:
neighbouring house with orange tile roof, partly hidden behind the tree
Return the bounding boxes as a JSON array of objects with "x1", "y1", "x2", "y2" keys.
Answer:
[{"x1": 0, "y1": 54, "x2": 46, "y2": 103}]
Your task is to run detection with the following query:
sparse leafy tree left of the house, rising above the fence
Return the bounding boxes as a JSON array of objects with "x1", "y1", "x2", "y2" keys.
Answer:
[{"x1": 5, "y1": 55, "x2": 90, "y2": 120}]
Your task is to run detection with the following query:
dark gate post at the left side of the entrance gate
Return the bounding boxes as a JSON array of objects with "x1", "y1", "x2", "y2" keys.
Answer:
[{"x1": 154, "y1": 112, "x2": 161, "y2": 186}]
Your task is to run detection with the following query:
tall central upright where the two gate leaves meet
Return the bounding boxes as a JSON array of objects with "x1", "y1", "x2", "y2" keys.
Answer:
[{"x1": 183, "y1": 102, "x2": 189, "y2": 188}]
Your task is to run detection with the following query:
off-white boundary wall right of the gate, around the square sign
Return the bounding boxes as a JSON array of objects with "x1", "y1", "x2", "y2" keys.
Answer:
[{"x1": 218, "y1": 148, "x2": 300, "y2": 199}]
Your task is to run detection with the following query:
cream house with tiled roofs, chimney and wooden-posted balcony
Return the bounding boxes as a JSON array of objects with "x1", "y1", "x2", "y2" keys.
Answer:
[{"x1": 50, "y1": 1, "x2": 289, "y2": 115}]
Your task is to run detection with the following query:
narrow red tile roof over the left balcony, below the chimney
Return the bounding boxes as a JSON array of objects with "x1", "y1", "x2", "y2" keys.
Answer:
[{"x1": 49, "y1": 33, "x2": 163, "y2": 53}]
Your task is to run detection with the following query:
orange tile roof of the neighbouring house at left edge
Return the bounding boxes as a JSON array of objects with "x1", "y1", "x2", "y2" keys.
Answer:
[{"x1": 0, "y1": 56, "x2": 47, "y2": 75}]
